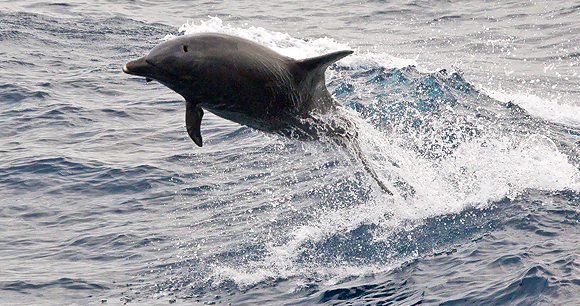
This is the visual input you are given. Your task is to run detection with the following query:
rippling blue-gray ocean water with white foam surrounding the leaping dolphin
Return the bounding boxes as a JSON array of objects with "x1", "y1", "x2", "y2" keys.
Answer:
[{"x1": 0, "y1": 0, "x2": 580, "y2": 305}]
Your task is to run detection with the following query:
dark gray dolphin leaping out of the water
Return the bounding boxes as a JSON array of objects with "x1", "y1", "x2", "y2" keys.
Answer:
[{"x1": 123, "y1": 33, "x2": 392, "y2": 195}]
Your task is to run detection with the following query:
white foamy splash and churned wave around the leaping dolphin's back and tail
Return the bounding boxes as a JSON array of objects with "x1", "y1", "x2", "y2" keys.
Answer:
[{"x1": 161, "y1": 17, "x2": 580, "y2": 288}]
